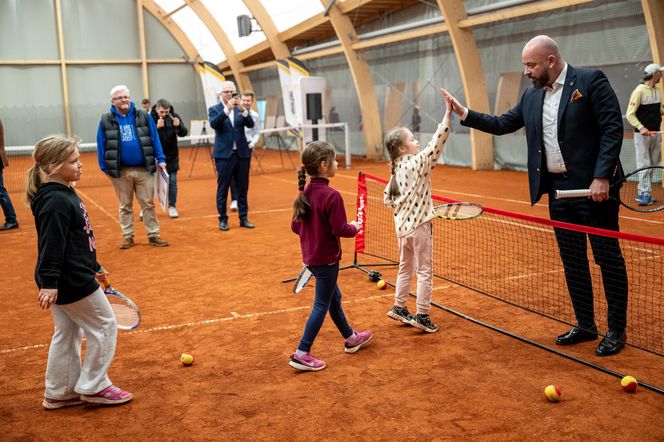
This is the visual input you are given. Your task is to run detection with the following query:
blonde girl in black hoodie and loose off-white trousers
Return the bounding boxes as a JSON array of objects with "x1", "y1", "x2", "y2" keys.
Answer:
[{"x1": 26, "y1": 135, "x2": 133, "y2": 410}]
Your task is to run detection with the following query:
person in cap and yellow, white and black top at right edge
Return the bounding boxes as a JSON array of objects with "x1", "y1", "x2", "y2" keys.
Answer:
[{"x1": 626, "y1": 63, "x2": 664, "y2": 206}]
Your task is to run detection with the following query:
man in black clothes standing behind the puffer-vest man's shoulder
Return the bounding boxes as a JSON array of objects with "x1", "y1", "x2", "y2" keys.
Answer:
[{"x1": 151, "y1": 98, "x2": 189, "y2": 218}]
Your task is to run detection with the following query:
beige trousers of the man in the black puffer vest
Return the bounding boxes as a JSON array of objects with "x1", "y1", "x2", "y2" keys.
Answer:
[{"x1": 111, "y1": 167, "x2": 159, "y2": 238}]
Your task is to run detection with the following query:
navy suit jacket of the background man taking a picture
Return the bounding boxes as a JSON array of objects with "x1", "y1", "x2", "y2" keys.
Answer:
[{"x1": 208, "y1": 103, "x2": 254, "y2": 159}]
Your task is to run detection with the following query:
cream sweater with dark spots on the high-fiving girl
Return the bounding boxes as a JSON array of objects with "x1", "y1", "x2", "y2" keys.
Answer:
[{"x1": 383, "y1": 119, "x2": 449, "y2": 238}]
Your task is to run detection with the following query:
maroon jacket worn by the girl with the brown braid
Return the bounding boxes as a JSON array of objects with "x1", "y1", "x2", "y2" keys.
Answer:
[{"x1": 291, "y1": 178, "x2": 357, "y2": 266}]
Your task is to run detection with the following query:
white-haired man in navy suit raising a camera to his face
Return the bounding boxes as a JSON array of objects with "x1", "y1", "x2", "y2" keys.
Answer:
[{"x1": 208, "y1": 81, "x2": 254, "y2": 231}]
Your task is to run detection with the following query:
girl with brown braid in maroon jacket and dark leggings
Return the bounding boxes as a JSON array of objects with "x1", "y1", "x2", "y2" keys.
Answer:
[{"x1": 288, "y1": 141, "x2": 373, "y2": 371}]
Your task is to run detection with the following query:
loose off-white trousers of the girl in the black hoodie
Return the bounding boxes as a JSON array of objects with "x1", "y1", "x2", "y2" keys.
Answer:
[{"x1": 44, "y1": 288, "x2": 117, "y2": 399}]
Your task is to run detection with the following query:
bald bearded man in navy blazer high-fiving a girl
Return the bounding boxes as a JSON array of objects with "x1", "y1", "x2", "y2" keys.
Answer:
[{"x1": 444, "y1": 35, "x2": 627, "y2": 356}]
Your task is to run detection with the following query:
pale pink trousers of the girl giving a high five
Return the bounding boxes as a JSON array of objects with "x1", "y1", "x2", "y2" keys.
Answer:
[{"x1": 394, "y1": 221, "x2": 433, "y2": 315}]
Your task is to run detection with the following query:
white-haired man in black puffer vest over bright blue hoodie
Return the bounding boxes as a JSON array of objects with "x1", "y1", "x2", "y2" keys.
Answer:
[{"x1": 97, "y1": 85, "x2": 168, "y2": 249}]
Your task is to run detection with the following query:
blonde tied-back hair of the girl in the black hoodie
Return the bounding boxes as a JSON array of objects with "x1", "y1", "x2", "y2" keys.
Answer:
[{"x1": 25, "y1": 135, "x2": 81, "y2": 205}]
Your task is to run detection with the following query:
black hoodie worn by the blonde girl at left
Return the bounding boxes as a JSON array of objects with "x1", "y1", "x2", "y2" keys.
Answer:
[{"x1": 30, "y1": 183, "x2": 100, "y2": 304}]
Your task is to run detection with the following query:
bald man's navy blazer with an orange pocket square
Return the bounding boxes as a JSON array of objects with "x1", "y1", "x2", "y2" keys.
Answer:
[{"x1": 461, "y1": 64, "x2": 623, "y2": 204}]
